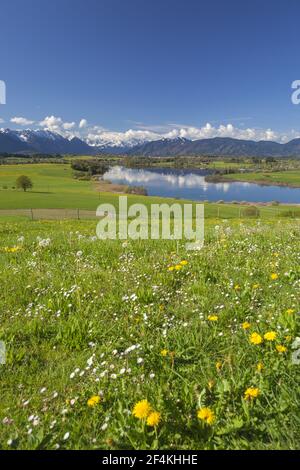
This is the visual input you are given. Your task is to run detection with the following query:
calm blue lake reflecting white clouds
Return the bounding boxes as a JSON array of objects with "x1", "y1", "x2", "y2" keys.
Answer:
[{"x1": 104, "y1": 166, "x2": 300, "y2": 203}]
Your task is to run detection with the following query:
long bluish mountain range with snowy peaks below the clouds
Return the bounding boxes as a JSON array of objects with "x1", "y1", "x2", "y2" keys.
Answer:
[{"x1": 0, "y1": 129, "x2": 300, "y2": 158}]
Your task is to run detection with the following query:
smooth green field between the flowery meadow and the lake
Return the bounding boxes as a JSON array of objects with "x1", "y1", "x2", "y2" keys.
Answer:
[{"x1": 0, "y1": 164, "x2": 299, "y2": 218}]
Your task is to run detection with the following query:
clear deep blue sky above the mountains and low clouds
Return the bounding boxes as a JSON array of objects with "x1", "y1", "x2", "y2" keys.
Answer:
[{"x1": 0, "y1": 0, "x2": 300, "y2": 142}]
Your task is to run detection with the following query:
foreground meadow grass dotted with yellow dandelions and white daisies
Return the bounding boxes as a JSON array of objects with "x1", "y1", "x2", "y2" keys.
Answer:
[{"x1": 0, "y1": 219, "x2": 300, "y2": 449}]
